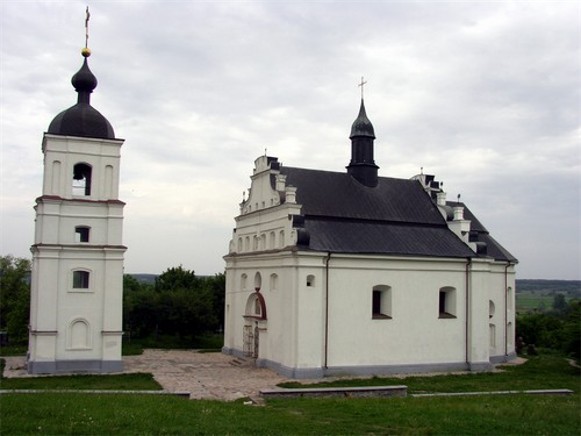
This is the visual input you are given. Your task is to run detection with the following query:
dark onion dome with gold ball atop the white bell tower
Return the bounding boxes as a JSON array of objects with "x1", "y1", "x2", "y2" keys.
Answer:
[{"x1": 48, "y1": 48, "x2": 115, "y2": 139}]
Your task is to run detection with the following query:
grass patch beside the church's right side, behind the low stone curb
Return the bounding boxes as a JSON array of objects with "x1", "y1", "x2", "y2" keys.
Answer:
[{"x1": 279, "y1": 354, "x2": 580, "y2": 393}]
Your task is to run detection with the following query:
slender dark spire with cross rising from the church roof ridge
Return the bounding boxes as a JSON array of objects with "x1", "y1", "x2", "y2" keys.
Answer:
[{"x1": 347, "y1": 77, "x2": 379, "y2": 188}]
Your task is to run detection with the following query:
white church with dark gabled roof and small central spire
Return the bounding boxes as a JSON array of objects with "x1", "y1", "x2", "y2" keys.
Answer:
[{"x1": 223, "y1": 96, "x2": 517, "y2": 378}]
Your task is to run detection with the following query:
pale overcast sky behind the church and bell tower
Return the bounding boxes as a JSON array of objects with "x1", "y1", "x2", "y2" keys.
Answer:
[{"x1": 0, "y1": 0, "x2": 581, "y2": 279}]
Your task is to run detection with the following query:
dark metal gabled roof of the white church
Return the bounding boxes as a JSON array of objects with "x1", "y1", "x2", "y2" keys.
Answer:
[{"x1": 280, "y1": 165, "x2": 516, "y2": 261}]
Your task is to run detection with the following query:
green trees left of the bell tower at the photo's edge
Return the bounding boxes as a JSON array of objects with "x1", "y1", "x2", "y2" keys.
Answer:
[{"x1": 0, "y1": 255, "x2": 30, "y2": 344}]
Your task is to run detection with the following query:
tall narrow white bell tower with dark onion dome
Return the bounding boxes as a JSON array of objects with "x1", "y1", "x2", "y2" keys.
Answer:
[{"x1": 28, "y1": 15, "x2": 126, "y2": 374}]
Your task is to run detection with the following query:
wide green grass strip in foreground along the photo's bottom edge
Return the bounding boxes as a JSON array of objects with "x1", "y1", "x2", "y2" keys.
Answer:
[{"x1": 0, "y1": 394, "x2": 580, "y2": 435}]
